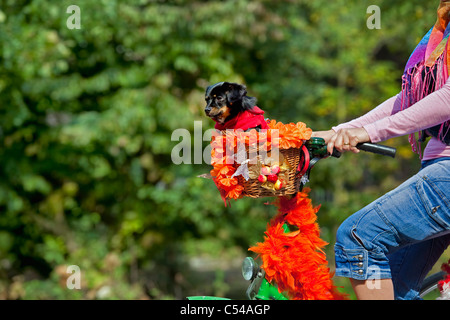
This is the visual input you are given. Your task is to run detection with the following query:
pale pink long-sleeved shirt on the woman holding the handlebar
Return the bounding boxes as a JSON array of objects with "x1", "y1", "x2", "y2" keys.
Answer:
[{"x1": 333, "y1": 77, "x2": 450, "y2": 160}]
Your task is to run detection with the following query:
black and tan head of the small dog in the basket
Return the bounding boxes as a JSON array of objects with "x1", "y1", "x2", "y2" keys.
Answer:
[{"x1": 205, "y1": 82, "x2": 256, "y2": 124}]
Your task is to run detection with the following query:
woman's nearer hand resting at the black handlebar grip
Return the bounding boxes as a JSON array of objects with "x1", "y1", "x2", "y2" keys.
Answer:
[{"x1": 325, "y1": 128, "x2": 370, "y2": 154}]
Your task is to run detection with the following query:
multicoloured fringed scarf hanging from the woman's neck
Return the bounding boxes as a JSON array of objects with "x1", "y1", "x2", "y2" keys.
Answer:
[{"x1": 402, "y1": 0, "x2": 450, "y2": 154}]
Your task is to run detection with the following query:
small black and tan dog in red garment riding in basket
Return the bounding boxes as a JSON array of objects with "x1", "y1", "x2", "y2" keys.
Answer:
[{"x1": 205, "y1": 82, "x2": 268, "y2": 131}]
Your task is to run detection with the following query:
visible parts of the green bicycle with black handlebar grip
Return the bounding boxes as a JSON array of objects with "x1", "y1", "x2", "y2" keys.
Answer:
[{"x1": 188, "y1": 137, "x2": 447, "y2": 300}]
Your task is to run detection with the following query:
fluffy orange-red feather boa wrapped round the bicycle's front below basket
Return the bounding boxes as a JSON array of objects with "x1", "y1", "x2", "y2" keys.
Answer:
[{"x1": 249, "y1": 191, "x2": 346, "y2": 300}]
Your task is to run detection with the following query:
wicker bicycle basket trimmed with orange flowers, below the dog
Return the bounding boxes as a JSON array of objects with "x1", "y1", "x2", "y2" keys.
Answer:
[{"x1": 211, "y1": 121, "x2": 311, "y2": 200}]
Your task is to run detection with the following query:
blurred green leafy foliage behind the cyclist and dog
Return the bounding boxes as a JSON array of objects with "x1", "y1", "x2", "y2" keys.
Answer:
[{"x1": 0, "y1": 0, "x2": 448, "y2": 299}]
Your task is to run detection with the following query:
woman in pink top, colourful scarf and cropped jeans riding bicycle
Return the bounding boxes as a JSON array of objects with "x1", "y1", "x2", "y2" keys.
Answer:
[{"x1": 313, "y1": 0, "x2": 450, "y2": 299}]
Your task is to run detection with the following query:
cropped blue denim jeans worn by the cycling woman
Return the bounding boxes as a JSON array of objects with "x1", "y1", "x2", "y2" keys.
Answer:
[{"x1": 335, "y1": 157, "x2": 450, "y2": 300}]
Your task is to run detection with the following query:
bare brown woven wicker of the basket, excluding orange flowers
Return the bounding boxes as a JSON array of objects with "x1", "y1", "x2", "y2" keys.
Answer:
[{"x1": 239, "y1": 148, "x2": 302, "y2": 198}]
